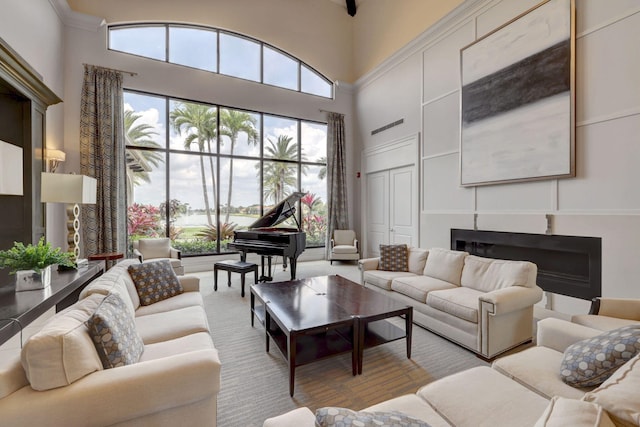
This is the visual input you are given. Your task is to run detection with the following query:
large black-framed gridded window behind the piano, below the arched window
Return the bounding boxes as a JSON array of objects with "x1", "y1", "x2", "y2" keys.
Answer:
[{"x1": 124, "y1": 91, "x2": 327, "y2": 256}]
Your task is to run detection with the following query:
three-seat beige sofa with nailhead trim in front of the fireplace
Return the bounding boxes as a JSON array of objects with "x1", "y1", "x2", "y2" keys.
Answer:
[{"x1": 359, "y1": 247, "x2": 542, "y2": 359}]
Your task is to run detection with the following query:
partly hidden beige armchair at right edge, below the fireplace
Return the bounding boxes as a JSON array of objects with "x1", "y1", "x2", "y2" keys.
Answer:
[{"x1": 571, "y1": 297, "x2": 640, "y2": 331}]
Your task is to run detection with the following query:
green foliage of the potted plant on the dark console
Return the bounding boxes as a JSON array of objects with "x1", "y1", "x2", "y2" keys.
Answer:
[{"x1": 0, "y1": 237, "x2": 75, "y2": 274}]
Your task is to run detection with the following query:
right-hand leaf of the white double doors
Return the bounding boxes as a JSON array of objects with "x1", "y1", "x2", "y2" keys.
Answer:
[{"x1": 389, "y1": 166, "x2": 418, "y2": 246}]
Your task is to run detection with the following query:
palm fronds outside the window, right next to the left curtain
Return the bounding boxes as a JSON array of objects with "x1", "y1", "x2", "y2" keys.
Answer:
[{"x1": 124, "y1": 110, "x2": 164, "y2": 205}]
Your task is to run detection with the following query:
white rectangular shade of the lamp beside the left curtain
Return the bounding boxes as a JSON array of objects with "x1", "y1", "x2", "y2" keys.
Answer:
[{"x1": 41, "y1": 172, "x2": 98, "y2": 204}]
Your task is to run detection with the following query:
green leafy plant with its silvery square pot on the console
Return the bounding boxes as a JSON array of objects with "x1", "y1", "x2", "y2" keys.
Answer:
[{"x1": 0, "y1": 237, "x2": 74, "y2": 291}]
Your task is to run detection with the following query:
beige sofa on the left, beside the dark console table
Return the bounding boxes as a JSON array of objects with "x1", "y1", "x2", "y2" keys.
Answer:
[{"x1": 0, "y1": 260, "x2": 221, "y2": 427}]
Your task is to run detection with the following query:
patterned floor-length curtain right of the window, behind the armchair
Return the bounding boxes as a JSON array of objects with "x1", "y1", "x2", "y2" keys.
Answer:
[{"x1": 326, "y1": 113, "x2": 349, "y2": 257}]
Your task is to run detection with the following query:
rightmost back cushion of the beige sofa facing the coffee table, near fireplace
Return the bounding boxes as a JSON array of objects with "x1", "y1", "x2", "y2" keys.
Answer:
[{"x1": 460, "y1": 255, "x2": 538, "y2": 292}]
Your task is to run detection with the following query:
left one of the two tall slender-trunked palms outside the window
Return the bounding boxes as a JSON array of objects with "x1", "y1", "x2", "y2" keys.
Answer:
[{"x1": 169, "y1": 103, "x2": 216, "y2": 226}]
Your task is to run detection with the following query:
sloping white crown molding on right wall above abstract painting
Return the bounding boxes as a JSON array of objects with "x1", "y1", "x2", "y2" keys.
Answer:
[{"x1": 354, "y1": 0, "x2": 495, "y2": 89}]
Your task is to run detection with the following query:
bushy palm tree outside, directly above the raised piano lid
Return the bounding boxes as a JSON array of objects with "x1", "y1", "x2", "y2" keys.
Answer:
[{"x1": 256, "y1": 135, "x2": 298, "y2": 203}]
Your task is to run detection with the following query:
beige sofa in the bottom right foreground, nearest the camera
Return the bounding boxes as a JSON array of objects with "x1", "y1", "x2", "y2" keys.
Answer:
[{"x1": 263, "y1": 318, "x2": 640, "y2": 427}]
